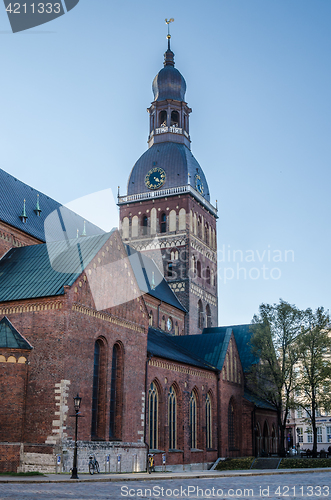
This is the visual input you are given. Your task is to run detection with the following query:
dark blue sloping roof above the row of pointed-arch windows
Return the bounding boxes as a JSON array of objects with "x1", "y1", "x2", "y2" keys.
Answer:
[{"x1": 147, "y1": 328, "x2": 215, "y2": 370}]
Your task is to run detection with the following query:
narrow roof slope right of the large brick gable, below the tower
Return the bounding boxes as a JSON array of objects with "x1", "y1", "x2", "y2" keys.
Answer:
[{"x1": 125, "y1": 245, "x2": 186, "y2": 312}]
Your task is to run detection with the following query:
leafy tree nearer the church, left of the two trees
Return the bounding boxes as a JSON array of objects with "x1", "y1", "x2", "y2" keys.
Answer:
[{"x1": 248, "y1": 299, "x2": 303, "y2": 456}]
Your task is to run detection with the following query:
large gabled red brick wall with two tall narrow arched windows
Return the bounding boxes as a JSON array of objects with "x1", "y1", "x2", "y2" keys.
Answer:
[{"x1": 0, "y1": 230, "x2": 148, "y2": 454}]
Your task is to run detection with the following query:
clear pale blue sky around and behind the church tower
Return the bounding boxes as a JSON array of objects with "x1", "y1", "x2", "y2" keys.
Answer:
[{"x1": 0, "y1": 0, "x2": 331, "y2": 325}]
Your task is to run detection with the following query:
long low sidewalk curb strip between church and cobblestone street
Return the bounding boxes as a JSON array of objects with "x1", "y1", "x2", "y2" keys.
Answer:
[{"x1": 0, "y1": 467, "x2": 331, "y2": 484}]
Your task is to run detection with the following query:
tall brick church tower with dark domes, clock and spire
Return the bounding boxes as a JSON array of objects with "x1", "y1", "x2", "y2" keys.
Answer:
[{"x1": 118, "y1": 34, "x2": 218, "y2": 335}]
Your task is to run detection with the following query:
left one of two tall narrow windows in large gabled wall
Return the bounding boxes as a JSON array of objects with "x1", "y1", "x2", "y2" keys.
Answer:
[{"x1": 91, "y1": 339, "x2": 106, "y2": 439}]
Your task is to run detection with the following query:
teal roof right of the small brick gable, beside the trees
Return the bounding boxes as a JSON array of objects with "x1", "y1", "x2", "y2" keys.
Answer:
[{"x1": 203, "y1": 325, "x2": 258, "y2": 371}]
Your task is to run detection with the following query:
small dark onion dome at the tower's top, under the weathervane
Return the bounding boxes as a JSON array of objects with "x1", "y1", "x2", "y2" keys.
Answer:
[{"x1": 152, "y1": 48, "x2": 186, "y2": 101}]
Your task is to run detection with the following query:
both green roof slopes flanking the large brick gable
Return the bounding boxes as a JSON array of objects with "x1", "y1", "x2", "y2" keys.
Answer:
[{"x1": 0, "y1": 229, "x2": 185, "y2": 312}]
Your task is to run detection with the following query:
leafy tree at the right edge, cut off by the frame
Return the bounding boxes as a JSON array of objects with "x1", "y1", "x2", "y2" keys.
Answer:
[{"x1": 297, "y1": 307, "x2": 331, "y2": 457}]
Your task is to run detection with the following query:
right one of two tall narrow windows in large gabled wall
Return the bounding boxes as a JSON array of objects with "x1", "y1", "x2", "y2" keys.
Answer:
[{"x1": 109, "y1": 344, "x2": 123, "y2": 439}]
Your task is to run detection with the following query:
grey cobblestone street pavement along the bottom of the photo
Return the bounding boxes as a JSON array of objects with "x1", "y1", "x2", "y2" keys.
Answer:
[{"x1": 0, "y1": 470, "x2": 331, "y2": 500}]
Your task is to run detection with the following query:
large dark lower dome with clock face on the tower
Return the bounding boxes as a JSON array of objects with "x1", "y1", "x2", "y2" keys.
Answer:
[{"x1": 127, "y1": 142, "x2": 210, "y2": 201}]
